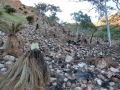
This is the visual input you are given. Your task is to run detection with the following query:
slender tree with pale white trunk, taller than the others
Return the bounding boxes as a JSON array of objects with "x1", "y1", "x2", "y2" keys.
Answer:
[{"x1": 69, "y1": 0, "x2": 113, "y2": 46}]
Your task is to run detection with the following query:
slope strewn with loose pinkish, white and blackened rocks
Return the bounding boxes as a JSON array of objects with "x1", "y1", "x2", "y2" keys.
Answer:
[{"x1": 0, "y1": 0, "x2": 120, "y2": 90}]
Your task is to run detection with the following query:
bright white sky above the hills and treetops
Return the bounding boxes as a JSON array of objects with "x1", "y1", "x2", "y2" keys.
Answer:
[{"x1": 20, "y1": 0, "x2": 117, "y2": 23}]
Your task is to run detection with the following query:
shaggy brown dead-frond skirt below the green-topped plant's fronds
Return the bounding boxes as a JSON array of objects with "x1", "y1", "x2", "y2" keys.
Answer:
[{"x1": 2, "y1": 35, "x2": 23, "y2": 57}]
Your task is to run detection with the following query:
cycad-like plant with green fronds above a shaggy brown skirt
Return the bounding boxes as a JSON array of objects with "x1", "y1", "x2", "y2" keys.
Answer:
[{"x1": 0, "y1": 21, "x2": 25, "y2": 57}]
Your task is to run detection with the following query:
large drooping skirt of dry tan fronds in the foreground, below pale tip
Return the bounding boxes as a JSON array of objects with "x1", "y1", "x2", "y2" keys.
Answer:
[{"x1": 0, "y1": 50, "x2": 50, "y2": 90}]
